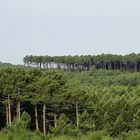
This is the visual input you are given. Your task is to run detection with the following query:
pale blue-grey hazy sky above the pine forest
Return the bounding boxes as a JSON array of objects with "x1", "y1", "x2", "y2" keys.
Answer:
[{"x1": 0, "y1": 0, "x2": 140, "y2": 64}]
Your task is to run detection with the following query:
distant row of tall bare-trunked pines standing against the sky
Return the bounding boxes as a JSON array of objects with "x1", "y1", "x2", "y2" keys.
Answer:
[{"x1": 23, "y1": 53, "x2": 140, "y2": 71}]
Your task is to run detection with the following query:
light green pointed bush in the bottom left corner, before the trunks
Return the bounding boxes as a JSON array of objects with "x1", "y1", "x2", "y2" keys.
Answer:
[{"x1": 0, "y1": 112, "x2": 43, "y2": 140}]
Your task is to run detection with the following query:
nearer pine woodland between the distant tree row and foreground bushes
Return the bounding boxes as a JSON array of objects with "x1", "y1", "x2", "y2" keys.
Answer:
[{"x1": 0, "y1": 68, "x2": 140, "y2": 136}]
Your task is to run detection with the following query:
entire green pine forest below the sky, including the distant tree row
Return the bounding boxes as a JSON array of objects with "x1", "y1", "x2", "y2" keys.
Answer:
[{"x1": 0, "y1": 54, "x2": 140, "y2": 140}]
